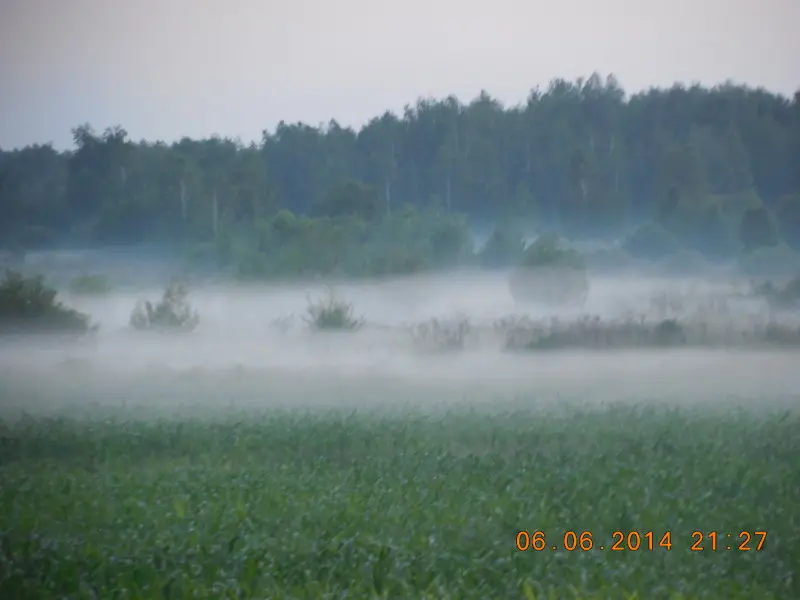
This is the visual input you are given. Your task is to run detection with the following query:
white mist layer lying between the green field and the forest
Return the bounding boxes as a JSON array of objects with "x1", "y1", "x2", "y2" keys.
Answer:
[{"x1": 0, "y1": 252, "x2": 800, "y2": 418}]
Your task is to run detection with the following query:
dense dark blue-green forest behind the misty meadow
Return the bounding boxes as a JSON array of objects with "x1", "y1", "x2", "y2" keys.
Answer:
[{"x1": 0, "y1": 74, "x2": 800, "y2": 276}]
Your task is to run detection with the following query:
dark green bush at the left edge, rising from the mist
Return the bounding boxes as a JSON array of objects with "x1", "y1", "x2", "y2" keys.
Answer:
[{"x1": 0, "y1": 271, "x2": 97, "y2": 334}]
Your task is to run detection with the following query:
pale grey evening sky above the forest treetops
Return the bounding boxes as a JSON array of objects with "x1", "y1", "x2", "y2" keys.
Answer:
[{"x1": 0, "y1": 0, "x2": 800, "y2": 149}]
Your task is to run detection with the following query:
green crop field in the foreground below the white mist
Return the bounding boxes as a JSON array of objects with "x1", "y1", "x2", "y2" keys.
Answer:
[{"x1": 0, "y1": 401, "x2": 800, "y2": 600}]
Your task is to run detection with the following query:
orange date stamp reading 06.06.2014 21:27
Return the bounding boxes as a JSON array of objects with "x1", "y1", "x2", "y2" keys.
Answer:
[{"x1": 515, "y1": 530, "x2": 767, "y2": 552}]
